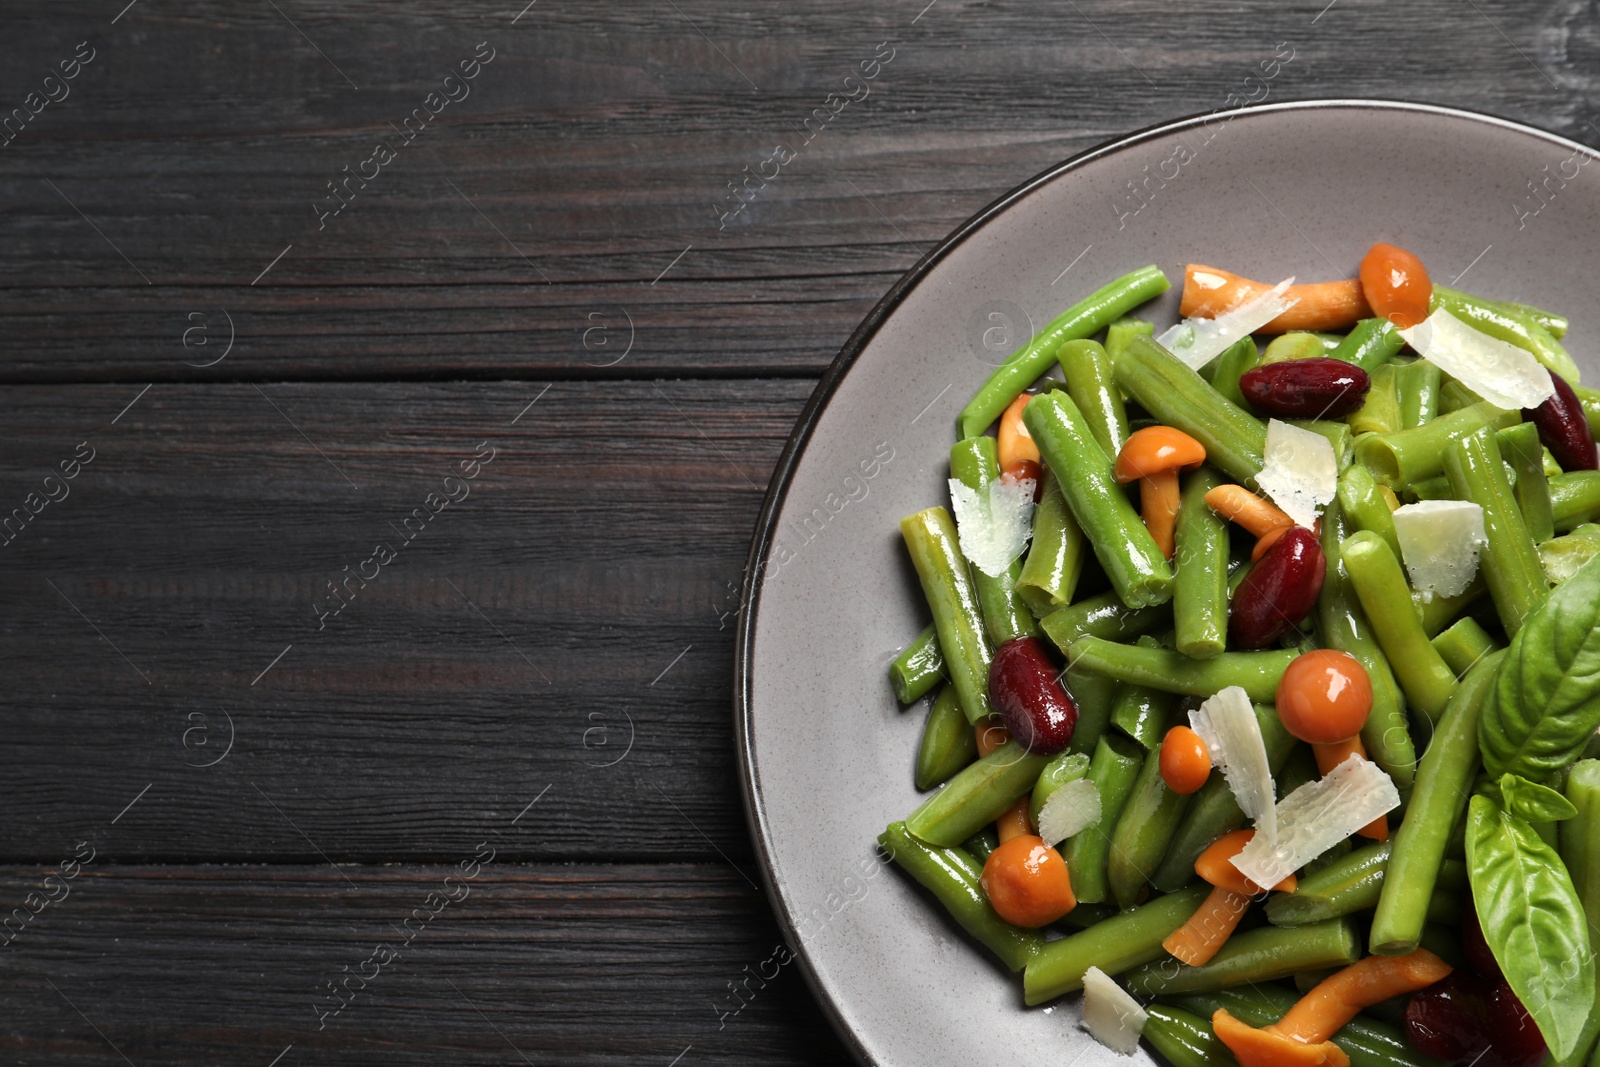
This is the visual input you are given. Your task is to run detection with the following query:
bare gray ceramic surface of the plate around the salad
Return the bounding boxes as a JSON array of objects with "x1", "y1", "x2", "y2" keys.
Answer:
[{"x1": 734, "y1": 101, "x2": 1600, "y2": 1067}]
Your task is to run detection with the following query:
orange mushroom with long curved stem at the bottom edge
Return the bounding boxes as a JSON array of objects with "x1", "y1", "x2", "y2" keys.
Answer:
[{"x1": 1211, "y1": 949, "x2": 1450, "y2": 1067}]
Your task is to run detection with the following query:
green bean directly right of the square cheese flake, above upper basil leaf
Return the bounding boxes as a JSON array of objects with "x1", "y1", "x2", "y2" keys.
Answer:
[{"x1": 1445, "y1": 434, "x2": 1550, "y2": 637}]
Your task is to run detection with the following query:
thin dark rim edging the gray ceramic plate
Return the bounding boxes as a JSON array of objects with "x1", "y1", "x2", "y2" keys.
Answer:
[{"x1": 733, "y1": 96, "x2": 1595, "y2": 1065}]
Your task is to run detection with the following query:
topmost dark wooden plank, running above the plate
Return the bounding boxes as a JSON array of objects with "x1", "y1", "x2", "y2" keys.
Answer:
[{"x1": 0, "y1": 0, "x2": 1592, "y2": 384}]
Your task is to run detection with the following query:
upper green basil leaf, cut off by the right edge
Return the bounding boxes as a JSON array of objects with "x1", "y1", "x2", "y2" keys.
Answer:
[{"x1": 1478, "y1": 557, "x2": 1600, "y2": 779}]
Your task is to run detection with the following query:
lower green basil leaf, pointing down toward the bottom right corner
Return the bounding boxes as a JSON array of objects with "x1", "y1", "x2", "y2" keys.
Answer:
[{"x1": 1467, "y1": 797, "x2": 1595, "y2": 1059}]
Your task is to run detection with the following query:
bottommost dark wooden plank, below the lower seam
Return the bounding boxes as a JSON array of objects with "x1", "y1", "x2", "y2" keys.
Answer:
[{"x1": 0, "y1": 863, "x2": 845, "y2": 1067}]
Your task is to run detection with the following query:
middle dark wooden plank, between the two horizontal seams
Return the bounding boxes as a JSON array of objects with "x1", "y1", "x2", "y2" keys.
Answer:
[{"x1": 0, "y1": 381, "x2": 810, "y2": 864}]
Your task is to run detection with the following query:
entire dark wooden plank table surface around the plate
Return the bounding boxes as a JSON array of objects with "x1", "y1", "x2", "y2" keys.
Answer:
[{"x1": 0, "y1": 0, "x2": 1600, "y2": 1067}]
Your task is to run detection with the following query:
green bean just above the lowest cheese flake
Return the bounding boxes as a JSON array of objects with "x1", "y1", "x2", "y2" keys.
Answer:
[{"x1": 1022, "y1": 885, "x2": 1210, "y2": 1006}]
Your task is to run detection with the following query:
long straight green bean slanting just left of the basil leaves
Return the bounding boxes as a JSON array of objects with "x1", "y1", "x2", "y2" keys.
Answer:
[{"x1": 1371, "y1": 653, "x2": 1504, "y2": 955}]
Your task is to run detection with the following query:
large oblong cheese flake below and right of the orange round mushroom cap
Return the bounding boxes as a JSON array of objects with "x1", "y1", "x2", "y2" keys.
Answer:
[{"x1": 1230, "y1": 755, "x2": 1400, "y2": 886}]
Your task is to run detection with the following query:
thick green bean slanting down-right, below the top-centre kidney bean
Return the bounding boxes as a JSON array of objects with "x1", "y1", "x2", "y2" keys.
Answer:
[{"x1": 1107, "y1": 338, "x2": 1267, "y2": 483}]
